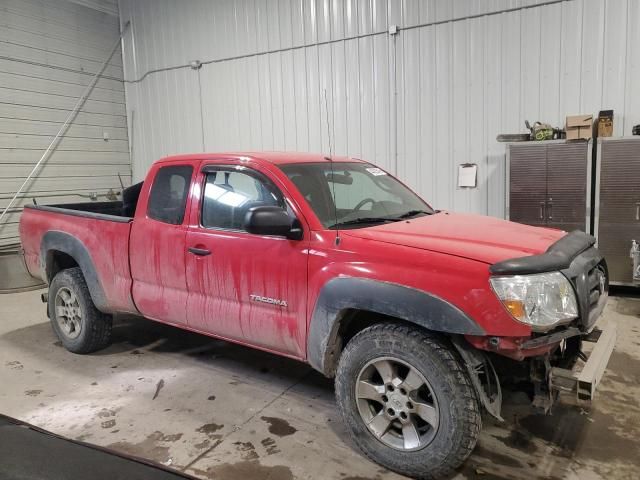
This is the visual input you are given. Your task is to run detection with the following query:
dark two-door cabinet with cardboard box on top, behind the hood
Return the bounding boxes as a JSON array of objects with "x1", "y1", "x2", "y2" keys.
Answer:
[{"x1": 507, "y1": 140, "x2": 591, "y2": 233}]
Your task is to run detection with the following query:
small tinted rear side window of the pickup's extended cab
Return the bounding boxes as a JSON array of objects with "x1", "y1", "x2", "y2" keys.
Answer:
[{"x1": 147, "y1": 165, "x2": 193, "y2": 225}]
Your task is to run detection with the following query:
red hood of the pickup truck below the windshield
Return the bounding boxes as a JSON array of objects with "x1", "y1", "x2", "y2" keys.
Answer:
[{"x1": 341, "y1": 212, "x2": 566, "y2": 265}]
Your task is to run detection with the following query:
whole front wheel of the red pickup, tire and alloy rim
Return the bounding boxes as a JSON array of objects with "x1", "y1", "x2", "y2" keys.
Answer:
[{"x1": 335, "y1": 323, "x2": 482, "y2": 478}]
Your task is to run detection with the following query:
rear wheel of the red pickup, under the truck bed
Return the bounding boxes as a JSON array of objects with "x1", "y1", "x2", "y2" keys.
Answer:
[{"x1": 48, "y1": 268, "x2": 113, "y2": 353}]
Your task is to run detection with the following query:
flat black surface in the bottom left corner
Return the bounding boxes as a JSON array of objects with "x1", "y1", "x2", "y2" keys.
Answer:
[{"x1": 0, "y1": 414, "x2": 194, "y2": 480}]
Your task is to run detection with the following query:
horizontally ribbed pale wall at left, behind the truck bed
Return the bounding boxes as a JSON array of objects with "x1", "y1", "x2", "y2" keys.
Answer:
[{"x1": 0, "y1": 0, "x2": 131, "y2": 246}]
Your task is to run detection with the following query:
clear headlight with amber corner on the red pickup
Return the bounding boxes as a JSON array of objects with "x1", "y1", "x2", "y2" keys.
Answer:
[{"x1": 491, "y1": 272, "x2": 578, "y2": 330}]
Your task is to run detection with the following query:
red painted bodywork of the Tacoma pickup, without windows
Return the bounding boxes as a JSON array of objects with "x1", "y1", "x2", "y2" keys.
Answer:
[{"x1": 20, "y1": 152, "x2": 564, "y2": 360}]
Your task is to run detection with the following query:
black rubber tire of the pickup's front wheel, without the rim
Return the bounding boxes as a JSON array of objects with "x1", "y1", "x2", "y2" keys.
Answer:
[{"x1": 335, "y1": 323, "x2": 482, "y2": 479}]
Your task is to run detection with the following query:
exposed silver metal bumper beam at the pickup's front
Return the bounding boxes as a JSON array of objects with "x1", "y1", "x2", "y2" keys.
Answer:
[{"x1": 548, "y1": 323, "x2": 617, "y2": 401}]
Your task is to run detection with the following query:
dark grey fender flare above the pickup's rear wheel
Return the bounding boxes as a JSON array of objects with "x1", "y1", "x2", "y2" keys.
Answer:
[{"x1": 40, "y1": 230, "x2": 109, "y2": 313}]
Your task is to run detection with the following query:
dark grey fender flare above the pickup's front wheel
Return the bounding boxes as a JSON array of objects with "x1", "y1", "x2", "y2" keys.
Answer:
[{"x1": 307, "y1": 277, "x2": 485, "y2": 376}]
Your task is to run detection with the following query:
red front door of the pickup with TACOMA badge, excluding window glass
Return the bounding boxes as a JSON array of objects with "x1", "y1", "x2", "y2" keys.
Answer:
[{"x1": 186, "y1": 160, "x2": 309, "y2": 358}]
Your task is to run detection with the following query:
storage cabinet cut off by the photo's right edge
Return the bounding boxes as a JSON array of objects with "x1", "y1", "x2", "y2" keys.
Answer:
[{"x1": 594, "y1": 137, "x2": 640, "y2": 286}]
